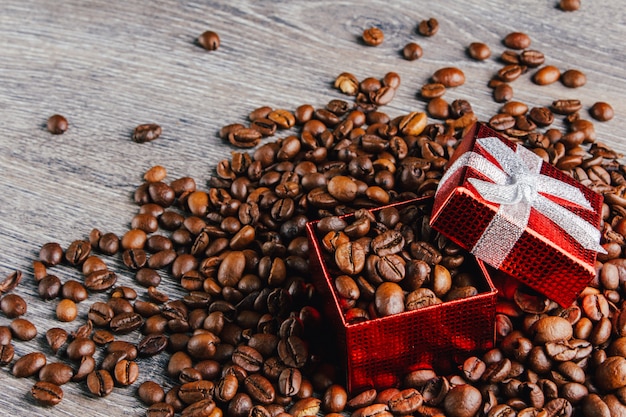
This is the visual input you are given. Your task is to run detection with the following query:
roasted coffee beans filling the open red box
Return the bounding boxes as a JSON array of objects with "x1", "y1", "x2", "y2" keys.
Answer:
[{"x1": 316, "y1": 201, "x2": 478, "y2": 318}]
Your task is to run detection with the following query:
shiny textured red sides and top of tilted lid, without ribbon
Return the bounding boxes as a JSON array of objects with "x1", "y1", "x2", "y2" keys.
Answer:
[{"x1": 431, "y1": 123, "x2": 602, "y2": 307}]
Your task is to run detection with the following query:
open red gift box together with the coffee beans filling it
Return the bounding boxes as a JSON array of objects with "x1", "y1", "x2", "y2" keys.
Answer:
[{"x1": 307, "y1": 197, "x2": 496, "y2": 392}]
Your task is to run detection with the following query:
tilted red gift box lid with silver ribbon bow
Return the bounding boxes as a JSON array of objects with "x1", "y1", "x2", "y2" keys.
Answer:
[{"x1": 431, "y1": 123, "x2": 604, "y2": 307}]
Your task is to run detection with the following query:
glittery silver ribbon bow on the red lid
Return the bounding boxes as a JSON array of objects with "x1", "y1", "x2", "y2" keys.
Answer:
[{"x1": 437, "y1": 137, "x2": 606, "y2": 268}]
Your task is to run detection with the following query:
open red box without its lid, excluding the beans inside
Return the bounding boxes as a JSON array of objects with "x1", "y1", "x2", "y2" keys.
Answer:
[{"x1": 306, "y1": 197, "x2": 497, "y2": 393}]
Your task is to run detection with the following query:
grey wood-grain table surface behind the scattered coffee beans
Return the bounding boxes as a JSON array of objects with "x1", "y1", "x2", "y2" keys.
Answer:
[{"x1": 0, "y1": 0, "x2": 626, "y2": 416}]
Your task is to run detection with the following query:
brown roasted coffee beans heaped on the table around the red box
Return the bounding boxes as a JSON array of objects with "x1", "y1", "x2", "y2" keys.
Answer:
[{"x1": 6, "y1": 17, "x2": 626, "y2": 417}]
